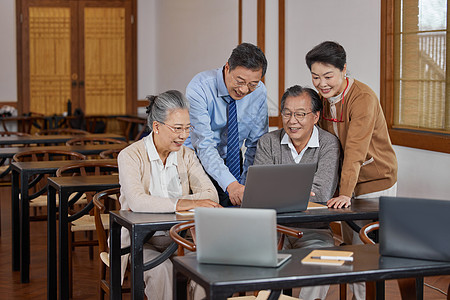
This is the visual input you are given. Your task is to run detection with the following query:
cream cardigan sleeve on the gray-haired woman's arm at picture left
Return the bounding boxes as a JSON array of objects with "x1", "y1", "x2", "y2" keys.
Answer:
[{"x1": 117, "y1": 145, "x2": 177, "y2": 213}]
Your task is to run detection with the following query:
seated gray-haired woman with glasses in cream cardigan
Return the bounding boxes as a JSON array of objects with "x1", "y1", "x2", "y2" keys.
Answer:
[{"x1": 117, "y1": 91, "x2": 220, "y2": 299}]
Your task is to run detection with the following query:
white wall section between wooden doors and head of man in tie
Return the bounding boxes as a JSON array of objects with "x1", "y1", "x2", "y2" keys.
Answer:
[{"x1": 144, "y1": 0, "x2": 238, "y2": 99}]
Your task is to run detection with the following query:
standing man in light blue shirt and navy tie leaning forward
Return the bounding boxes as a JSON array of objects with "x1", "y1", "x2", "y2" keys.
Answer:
[{"x1": 185, "y1": 43, "x2": 268, "y2": 206}]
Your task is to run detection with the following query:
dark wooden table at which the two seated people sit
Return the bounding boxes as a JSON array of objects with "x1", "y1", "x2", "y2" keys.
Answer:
[{"x1": 110, "y1": 199, "x2": 378, "y2": 299}]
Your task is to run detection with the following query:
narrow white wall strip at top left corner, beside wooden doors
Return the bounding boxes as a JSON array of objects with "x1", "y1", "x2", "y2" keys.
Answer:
[{"x1": 0, "y1": 0, "x2": 17, "y2": 102}]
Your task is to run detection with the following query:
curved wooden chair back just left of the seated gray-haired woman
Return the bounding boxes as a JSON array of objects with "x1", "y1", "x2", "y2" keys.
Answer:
[{"x1": 92, "y1": 188, "x2": 120, "y2": 253}]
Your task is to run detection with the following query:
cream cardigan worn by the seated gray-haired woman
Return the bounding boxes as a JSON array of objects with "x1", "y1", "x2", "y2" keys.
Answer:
[{"x1": 117, "y1": 140, "x2": 219, "y2": 213}]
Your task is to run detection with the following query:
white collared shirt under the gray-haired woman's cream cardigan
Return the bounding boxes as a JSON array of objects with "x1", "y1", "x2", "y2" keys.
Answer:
[{"x1": 144, "y1": 132, "x2": 183, "y2": 236}]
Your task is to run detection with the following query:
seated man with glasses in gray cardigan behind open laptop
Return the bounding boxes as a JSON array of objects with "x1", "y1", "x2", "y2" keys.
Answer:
[{"x1": 255, "y1": 85, "x2": 339, "y2": 300}]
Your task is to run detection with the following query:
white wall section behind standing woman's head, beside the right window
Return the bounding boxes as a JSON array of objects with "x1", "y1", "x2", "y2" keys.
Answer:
[{"x1": 286, "y1": 0, "x2": 381, "y2": 95}]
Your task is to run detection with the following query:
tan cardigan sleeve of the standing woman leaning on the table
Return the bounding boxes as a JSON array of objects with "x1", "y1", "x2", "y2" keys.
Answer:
[{"x1": 339, "y1": 93, "x2": 378, "y2": 197}]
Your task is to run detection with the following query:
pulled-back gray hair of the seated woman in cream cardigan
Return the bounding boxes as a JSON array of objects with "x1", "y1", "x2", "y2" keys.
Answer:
[{"x1": 145, "y1": 90, "x2": 189, "y2": 126}]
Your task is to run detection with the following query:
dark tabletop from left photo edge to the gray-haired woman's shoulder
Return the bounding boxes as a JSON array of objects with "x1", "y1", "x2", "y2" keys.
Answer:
[{"x1": 0, "y1": 133, "x2": 125, "y2": 146}]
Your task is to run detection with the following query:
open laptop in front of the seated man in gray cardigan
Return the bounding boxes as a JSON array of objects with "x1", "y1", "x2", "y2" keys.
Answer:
[{"x1": 241, "y1": 164, "x2": 316, "y2": 213}]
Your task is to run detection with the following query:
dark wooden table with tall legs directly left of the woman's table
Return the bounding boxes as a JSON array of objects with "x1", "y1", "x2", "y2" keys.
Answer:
[{"x1": 47, "y1": 175, "x2": 119, "y2": 299}]
